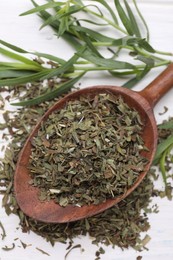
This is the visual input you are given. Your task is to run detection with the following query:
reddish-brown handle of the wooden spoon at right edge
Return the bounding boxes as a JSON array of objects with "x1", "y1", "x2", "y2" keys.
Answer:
[{"x1": 139, "y1": 63, "x2": 173, "y2": 108}]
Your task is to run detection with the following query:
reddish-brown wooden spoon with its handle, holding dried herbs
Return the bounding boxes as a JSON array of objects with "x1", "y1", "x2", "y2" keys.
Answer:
[{"x1": 14, "y1": 64, "x2": 173, "y2": 223}]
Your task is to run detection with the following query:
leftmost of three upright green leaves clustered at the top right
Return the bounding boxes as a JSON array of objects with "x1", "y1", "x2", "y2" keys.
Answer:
[{"x1": 114, "y1": 0, "x2": 134, "y2": 35}]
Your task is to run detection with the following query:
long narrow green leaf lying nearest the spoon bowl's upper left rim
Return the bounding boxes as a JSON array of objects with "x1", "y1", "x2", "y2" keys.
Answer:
[{"x1": 11, "y1": 72, "x2": 85, "y2": 106}]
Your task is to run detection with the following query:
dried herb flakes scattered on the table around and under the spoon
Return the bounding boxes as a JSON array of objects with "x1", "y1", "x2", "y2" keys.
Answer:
[{"x1": 0, "y1": 82, "x2": 173, "y2": 254}]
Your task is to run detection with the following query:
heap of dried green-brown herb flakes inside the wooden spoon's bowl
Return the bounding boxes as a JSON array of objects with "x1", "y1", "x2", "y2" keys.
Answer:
[{"x1": 28, "y1": 94, "x2": 147, "y2": 206}]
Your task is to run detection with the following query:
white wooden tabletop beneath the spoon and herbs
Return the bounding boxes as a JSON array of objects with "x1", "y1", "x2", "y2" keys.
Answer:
[{"x1": 0, "y1": 0, "x2": 173, "y2": 260}]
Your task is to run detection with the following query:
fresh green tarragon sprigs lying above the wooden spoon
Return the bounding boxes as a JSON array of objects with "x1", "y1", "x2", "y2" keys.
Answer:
[{"x1": 0, "y1": 0, "x2": 172, "y2": 105}]
